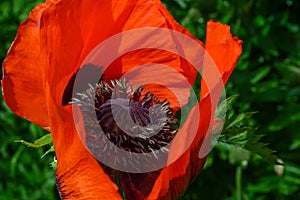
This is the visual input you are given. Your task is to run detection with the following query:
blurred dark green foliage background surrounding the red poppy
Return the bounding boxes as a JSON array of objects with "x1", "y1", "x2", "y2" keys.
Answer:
[{"x1": 0, "y1": 0, "x2": 300, "y2": 200}]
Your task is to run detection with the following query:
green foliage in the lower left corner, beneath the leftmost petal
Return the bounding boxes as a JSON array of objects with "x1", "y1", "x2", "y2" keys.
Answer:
[{"x1": 0, "y1": 101, "x2": 57, "y2": 200}]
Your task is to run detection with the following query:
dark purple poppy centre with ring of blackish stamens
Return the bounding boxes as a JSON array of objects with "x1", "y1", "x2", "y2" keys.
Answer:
[{"x1": 72, "y1": 80, "x2": 178, "y2": 162}]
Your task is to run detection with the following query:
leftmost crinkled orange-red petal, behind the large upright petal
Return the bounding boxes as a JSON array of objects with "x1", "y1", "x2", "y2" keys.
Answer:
[{"x1": 2, "y1": 4, "x2": 49, "y2": 127}]
